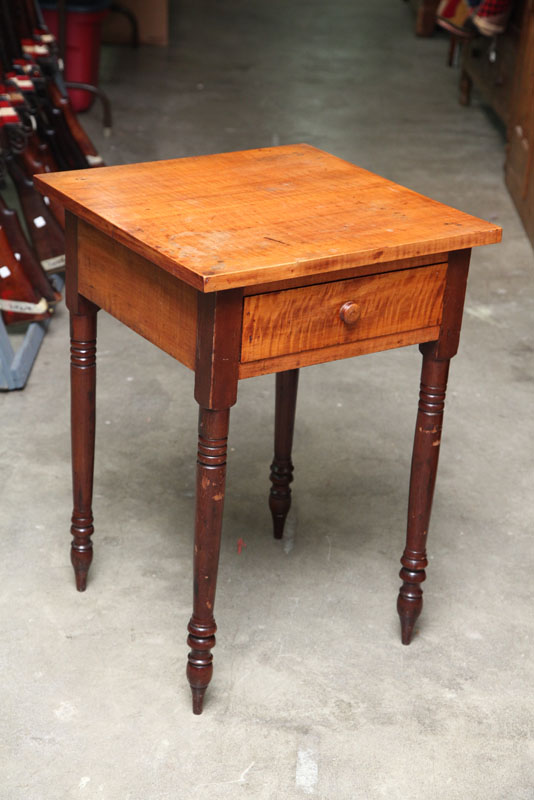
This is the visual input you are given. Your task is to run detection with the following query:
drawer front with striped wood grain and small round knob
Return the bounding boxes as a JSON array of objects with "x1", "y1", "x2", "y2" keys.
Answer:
[{"x1": 241, "y1": 264, "x2": 447, "y2": 362}]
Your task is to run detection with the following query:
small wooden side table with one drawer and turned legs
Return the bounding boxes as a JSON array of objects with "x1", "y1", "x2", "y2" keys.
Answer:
[{"x1": 35, "y1": 144, "x2": 501, "y2": 714}]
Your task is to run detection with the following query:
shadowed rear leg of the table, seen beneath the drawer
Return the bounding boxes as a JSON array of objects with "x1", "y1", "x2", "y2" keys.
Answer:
[{"x1": 269, "y1": 369, "x2": 299, "y2": 539}]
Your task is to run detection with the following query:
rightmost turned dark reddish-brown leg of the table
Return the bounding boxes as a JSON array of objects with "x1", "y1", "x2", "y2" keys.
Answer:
[{"x1": 397, "y1": 343, "x2": 450, "y2": 644}]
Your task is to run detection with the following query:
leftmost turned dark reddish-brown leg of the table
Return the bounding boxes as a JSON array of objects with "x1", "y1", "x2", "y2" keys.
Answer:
[{"x1": 70, "y1": 299, "x2": 98, "y2": 592}]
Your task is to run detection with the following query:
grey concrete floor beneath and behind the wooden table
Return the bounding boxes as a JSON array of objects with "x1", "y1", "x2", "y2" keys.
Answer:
[{"x1": 0, "y1": 0, "x2": 534, "y2": 800}]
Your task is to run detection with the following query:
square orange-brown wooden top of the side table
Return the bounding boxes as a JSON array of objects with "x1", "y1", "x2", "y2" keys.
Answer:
[{"x1": 35, "y1": 144, "x2": 501, "y2": 292}]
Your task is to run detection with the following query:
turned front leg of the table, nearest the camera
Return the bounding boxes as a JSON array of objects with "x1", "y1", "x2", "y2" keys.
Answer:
[{"x1": 187, "y1": 407, "x2": 230, "y2": 714}]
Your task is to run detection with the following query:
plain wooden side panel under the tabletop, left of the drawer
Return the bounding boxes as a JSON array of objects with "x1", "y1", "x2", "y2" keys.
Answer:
[{"x1": 77, "y1": 221, "x2": 198, "y2": 369}]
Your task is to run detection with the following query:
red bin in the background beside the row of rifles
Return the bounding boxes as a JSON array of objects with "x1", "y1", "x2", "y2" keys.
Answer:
[{"x1": 43, "y1": 9, "x2": 108, "y2": 111}]
